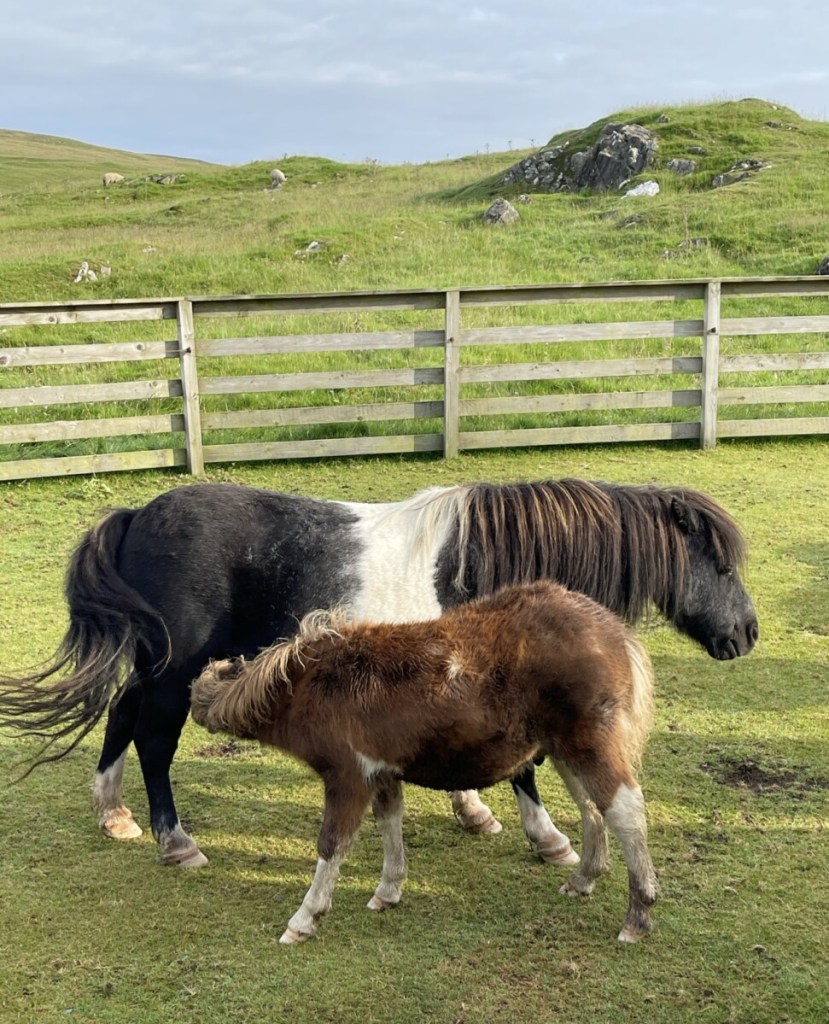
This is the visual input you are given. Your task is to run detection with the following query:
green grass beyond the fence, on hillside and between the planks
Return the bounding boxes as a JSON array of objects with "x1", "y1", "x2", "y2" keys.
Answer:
[{"x1": 0, "y1": 100, "x2": 829, "y2": 468}]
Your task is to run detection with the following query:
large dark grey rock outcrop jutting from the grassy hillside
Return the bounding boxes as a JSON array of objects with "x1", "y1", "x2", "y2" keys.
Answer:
[{"x1": 503, "y1": 124, "x2": 659, "y2": 193}]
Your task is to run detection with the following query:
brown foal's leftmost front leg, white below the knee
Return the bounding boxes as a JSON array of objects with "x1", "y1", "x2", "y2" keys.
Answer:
[{"x1": 279, "y1": 775, "x2": 372, "y2": 945}]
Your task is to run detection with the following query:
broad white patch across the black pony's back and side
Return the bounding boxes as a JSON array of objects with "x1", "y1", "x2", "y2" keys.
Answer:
[{"x1": 342, "y1": 487, "x2": 462, "y2": 623}]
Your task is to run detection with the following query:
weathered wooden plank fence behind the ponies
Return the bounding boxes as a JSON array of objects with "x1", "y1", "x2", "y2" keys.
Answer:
[{"x1": 0, "y1": 278, "x2": 829, "y2": 480}]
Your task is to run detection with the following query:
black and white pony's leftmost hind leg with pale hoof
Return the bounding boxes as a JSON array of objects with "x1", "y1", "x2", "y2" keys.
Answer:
[{"x1": 92, "y1": 683, "x2": 141, "y2": 839}]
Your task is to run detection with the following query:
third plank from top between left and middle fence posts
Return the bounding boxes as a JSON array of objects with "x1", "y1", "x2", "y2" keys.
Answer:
[{"x1": 199, "y1": 367, "x2": 443, "y2": 394}]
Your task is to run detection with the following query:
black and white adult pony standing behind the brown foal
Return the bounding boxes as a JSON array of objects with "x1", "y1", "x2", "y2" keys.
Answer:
[{"x1": 0, "y1": 479, "x2": 757, "y2": 866}]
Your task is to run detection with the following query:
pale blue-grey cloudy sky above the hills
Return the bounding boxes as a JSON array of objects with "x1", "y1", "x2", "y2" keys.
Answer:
[{"x1": 0, "y1": 0, "x2": 829, "y2": 164}]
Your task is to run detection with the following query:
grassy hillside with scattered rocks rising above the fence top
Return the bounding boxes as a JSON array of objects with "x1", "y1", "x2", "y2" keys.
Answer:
[{"x1": 0, "y1": 99, "x2": 829, "y2": 302}]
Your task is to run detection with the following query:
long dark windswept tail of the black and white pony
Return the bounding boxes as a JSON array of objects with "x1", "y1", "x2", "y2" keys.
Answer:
[{"x1": 0, "y1": 509, "x2": 169, "y2": 777}]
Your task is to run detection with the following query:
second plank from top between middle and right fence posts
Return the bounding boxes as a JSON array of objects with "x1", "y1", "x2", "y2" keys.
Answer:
[{"x1": 461, "y1": 319, "x2": 702, "y2": 345}]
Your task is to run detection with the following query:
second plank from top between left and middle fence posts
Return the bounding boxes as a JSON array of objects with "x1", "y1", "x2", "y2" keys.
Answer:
[{"x1": 199, "y1": 331, "x2": 443, "y2": 357}]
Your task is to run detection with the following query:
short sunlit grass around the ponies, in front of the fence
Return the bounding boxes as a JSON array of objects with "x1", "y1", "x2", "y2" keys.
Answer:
[{"x1": 0, "y1": 439, "x2": 829, "y2": 1024}]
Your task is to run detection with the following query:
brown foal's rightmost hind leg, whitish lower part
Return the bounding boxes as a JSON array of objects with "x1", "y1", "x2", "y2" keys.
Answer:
[{"x1": 605, "y1": 783, "x2": 659, "y2": 942}]
